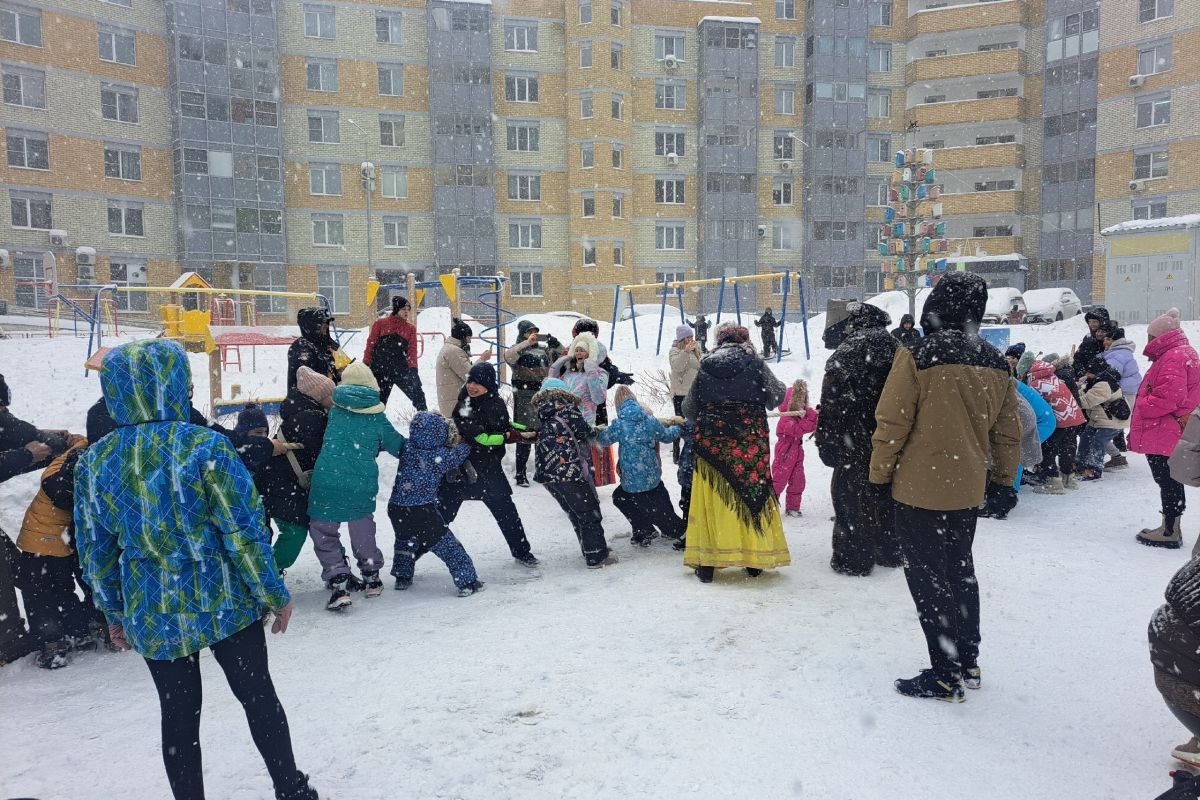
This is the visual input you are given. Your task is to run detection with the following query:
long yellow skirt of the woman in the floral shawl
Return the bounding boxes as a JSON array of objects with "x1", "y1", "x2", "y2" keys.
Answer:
[{"x1": 683, "y1": 469, "x2": 792, "y2": 570}]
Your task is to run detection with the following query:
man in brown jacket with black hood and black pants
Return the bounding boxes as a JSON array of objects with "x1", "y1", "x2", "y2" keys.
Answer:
[{"x1": 870, "y1": 272, "x2": 1021, "y2": 702}]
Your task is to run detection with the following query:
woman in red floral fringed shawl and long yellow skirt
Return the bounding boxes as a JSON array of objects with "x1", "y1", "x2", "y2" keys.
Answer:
[{"x1": 683, "y1": 325, "x2": 791, "y2": 583}]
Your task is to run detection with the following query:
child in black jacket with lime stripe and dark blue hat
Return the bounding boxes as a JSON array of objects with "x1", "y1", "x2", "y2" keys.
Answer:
[{"x1": 438, "y1": 362, "x2": 538, "y2": 567}]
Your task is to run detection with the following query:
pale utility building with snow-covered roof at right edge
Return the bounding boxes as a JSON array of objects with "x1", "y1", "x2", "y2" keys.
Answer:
[{"x1": 1100, "y1": 213, "x2": 1200, "y2": 324}]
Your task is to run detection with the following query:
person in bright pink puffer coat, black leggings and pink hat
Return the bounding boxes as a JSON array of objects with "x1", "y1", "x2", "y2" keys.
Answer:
[{"x1": 1129, "y1": 308, "x2": 1200, "y2": 549}]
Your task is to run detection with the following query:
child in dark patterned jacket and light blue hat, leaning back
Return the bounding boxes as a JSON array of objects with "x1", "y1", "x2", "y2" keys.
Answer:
[{"x1": 533, "y1": 378, "x2": 617, "y2": 570}]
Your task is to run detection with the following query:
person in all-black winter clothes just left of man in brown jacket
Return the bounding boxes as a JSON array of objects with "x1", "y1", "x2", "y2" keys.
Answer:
[{"x1": 816, "y1": 302, "x2": 901, "y2": 576}]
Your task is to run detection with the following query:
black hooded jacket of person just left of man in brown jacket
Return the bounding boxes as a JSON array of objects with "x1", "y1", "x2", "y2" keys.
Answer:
[{"x1": 816, "y1": 302, "x2": 900, "y2": 468}]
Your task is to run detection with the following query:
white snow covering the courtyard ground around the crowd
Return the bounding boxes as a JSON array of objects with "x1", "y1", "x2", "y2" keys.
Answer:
[{"x1": 0, "y1": 312, "x2": 1185, "y2": 800}]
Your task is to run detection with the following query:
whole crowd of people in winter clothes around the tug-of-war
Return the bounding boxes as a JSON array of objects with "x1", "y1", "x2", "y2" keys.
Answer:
[{"x1": 7, "y1": 273, "x2": 1200, "y2": 799}]
